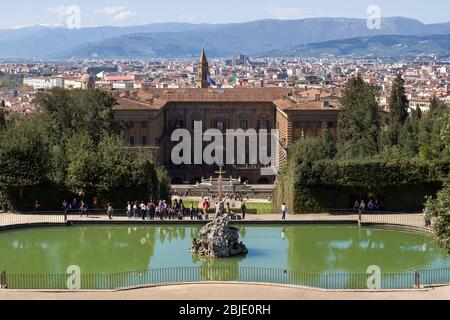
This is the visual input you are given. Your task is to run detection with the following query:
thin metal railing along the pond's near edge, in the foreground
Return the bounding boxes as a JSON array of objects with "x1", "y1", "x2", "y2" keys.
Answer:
[{"x1": 0, "y1": 266, "x2": 450, "y2": 290}]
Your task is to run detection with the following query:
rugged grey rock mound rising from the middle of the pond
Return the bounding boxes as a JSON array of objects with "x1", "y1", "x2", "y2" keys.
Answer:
[{"x1": 190, "y1": 217, "x2": 248, "y2": 258}]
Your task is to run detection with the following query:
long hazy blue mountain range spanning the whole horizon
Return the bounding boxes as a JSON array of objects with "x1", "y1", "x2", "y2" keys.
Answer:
[{"x1": 0, "y1": 17, "x2": 450, "y2": 59}]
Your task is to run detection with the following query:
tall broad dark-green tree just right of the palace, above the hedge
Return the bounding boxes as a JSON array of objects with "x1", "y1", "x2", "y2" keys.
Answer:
[{"x1": 337, "y1": 75, "x2": 380, "y2": 158}]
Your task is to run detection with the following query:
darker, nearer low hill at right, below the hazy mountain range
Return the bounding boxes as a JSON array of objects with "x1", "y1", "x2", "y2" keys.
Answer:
[{"x1": 261, "y1": 34, "x2": 450, "y2": 57}]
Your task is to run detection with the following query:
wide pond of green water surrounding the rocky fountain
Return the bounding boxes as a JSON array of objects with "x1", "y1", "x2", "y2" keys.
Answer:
[{"x1": 0, "y1": 225, "x2": 450, "y2": 274}]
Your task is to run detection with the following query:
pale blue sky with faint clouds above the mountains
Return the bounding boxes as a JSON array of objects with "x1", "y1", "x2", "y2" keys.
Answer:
[{"x1": 0, "y1": 0, "x2": 450, "y2": 29}]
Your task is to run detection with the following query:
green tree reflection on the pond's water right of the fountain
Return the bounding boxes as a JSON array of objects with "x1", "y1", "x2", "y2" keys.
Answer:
[{"x1": 286, "y1": 227, "x2": 450, "y2": 274}]
